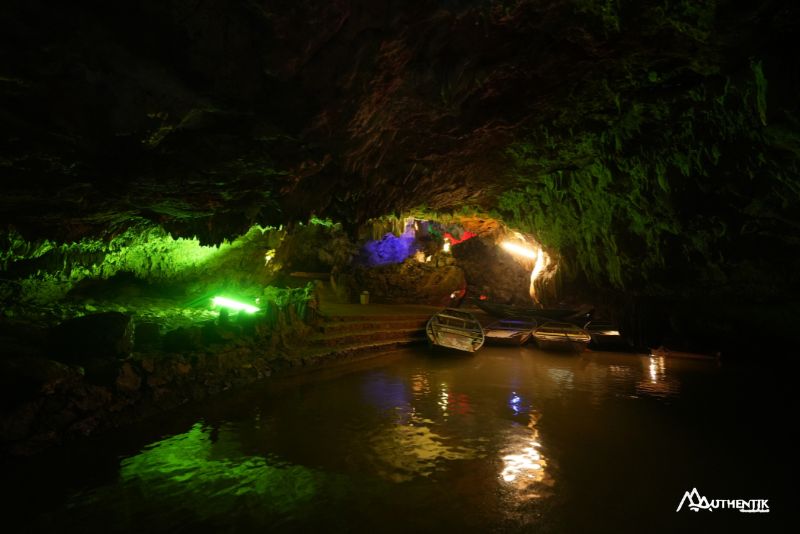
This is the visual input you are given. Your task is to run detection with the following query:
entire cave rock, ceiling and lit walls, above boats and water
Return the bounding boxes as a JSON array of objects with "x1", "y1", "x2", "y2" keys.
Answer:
[{"x1": 0, "y1": 0, "x2": 800, "y2": 456}]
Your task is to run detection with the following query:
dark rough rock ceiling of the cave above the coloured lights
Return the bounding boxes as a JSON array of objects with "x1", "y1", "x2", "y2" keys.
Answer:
[{"x1": 0, "y1": 0, "x2": 800, "y2": 294}]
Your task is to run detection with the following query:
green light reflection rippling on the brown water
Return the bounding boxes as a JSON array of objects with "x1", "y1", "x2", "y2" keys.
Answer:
[{"x1": 69, "y1": 422, "x2": 330, "y2": 531}]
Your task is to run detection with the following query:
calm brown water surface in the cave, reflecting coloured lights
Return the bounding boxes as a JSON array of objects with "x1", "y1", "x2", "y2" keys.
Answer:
[{"x1": 3, "y1": 348, "x2": 790, "y2": 533}]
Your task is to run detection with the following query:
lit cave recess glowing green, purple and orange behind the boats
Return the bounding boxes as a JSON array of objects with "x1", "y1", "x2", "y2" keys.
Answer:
[{"x1": 2, "y1": 215, "x2": 558, "y2": 342}]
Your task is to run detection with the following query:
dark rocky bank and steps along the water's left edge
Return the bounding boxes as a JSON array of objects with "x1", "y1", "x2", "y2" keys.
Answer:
[{"x1": 0, "y1": 286, "x2": 432, "y2": 455}]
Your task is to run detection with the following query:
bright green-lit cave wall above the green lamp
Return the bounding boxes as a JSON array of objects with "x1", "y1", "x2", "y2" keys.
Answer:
[{"x1": 0, "y1": 224, "x2": 280, "y2": 306}]
